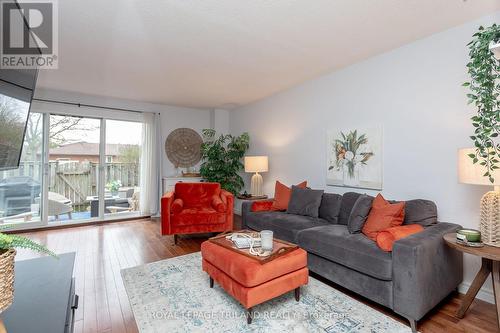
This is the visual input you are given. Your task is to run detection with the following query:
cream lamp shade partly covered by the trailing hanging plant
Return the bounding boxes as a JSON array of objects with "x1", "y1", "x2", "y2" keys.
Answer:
[{"x1": 458, "y1": 148, "x2": 500, "y2": 186}]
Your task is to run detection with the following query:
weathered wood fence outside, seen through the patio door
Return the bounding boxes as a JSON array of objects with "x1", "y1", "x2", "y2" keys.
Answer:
[{"x1": 0, "y1": 161, "x2": 140, "y2": 211}]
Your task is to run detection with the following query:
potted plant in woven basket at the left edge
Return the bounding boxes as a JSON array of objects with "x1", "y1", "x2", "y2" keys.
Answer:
[{"x1": 0, "y1": 227, "x2": 57, "y2": 320}]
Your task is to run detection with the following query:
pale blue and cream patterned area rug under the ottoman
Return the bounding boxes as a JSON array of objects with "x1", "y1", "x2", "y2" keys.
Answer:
[{"x1": 121, "y1": 252, "x2": 411, "y2": 333}]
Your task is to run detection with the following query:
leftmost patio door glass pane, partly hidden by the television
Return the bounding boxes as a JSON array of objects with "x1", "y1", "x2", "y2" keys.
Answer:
[{"x1": 0, "y1": 112, "x2": 43, "y2": 224}]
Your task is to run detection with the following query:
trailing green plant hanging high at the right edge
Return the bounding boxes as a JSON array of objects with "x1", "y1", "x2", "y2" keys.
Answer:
[{"x1": 463, "y1": 24, "x2": 500, "y2": 183}]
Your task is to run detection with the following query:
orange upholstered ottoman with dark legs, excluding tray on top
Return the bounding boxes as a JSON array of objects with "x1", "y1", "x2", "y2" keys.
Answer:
[{"x1": 201, "y1": 241, "x2": 309, "y2": 324}]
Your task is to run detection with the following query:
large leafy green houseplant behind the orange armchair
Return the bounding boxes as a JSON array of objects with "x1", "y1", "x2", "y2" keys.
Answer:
[{"x1": 200, "y1": 129, "x2": 250, "y2": 195}]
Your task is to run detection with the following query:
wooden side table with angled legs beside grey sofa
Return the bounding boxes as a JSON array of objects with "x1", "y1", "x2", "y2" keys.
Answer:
[{"x1": 443, "y1": 233, "x2": 500, "y2": 327}]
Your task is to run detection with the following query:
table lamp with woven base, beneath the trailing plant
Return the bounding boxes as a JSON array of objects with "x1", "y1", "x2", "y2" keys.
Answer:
[{"x1": 458, "y1": 148, "x2": 500, "y2": 247}]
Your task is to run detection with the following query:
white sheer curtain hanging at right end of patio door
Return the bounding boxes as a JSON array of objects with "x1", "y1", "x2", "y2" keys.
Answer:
[{"x1": 139, "y1": 113, "x2": 161, "y2": 216}]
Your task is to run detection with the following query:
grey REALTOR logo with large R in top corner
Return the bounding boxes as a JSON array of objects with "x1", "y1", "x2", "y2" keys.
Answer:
[{"x1": 0, "y1": 0, "x2": 58, "y2": 69}]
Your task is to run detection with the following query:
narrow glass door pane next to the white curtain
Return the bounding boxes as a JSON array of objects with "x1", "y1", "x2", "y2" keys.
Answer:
[{"x1": 105, "y1": 120, "x2": 142, "y2": 216}]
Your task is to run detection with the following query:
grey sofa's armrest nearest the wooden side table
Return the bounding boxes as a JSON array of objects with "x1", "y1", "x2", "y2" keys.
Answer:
[{"x1": 392, "y1": 222, "x2": 463, "y2": 320}]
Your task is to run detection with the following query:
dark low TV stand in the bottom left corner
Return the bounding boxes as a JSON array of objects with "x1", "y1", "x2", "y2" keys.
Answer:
[{"x1": 0, "y1": 253, "x2": 78, "y2": 333}]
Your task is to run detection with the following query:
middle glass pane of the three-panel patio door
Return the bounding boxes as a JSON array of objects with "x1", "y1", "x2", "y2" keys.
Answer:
[{"x1": 48, "y1": 115, "x2": 101, "y2": 222}]
